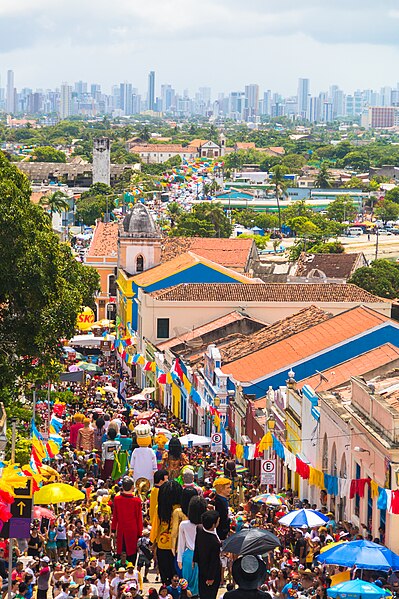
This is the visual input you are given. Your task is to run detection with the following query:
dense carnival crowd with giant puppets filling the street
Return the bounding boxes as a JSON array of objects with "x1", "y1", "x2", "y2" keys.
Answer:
[{"x1": 0, "y1": 358, "x2": 399, "y2": 599}]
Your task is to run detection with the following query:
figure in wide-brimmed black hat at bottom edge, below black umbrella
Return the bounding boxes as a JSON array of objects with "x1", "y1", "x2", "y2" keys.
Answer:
[{"x1": 224, "y1": 555, "x2": 272, "y2": 599}]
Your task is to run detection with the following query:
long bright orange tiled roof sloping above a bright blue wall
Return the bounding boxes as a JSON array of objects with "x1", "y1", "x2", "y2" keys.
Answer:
[{"x1": 222, "y1": 306, "x2": 390, "y2": 383}]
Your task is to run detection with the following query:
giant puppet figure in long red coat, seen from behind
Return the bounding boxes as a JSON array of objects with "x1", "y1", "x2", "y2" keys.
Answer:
[{"x1": 111, "y1": 476, "x2": 143, "y2": 564}]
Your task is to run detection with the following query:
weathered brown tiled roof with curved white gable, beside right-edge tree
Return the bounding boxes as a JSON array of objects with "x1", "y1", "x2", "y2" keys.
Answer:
[{"x1": 295, "y1": 252, "x2": 361, "y2": 279}]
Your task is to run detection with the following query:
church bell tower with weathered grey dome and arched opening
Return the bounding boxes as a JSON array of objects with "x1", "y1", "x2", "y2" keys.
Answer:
[{"x1": 118, "y1": 202, "x2": 162, "y2": 275}]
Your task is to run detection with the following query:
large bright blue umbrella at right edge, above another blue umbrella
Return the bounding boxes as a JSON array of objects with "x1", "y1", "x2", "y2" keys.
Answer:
[{"x1": 316, "y1": 541, "x2": 399, "y2": 571}]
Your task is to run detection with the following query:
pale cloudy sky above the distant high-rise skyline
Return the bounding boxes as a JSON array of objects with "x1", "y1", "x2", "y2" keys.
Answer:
[{"x1": 0, "y1": 0, "x2": 399, "y2": 96}]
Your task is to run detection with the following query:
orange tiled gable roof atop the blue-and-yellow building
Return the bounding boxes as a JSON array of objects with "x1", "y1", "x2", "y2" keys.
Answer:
[{"x1": 134, "y1": 252, "x2": 254, "y2": 293}]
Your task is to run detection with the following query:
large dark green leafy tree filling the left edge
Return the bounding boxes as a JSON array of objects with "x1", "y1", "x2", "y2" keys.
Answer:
[{"x1": 0, "y1": 152, "x2": 99, "y2": 401}]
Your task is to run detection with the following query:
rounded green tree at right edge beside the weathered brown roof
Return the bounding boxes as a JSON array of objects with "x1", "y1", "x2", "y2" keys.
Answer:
[{"x1": 348, "y1": 260, "x2": 399, "y2": 299}]
